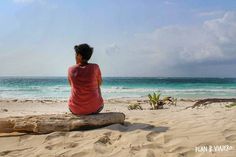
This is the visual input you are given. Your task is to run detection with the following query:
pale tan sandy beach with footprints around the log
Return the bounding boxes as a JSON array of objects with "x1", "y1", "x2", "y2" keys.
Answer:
[{"x1": 0, "y1": 98, "x2": 236, "y2": 157}]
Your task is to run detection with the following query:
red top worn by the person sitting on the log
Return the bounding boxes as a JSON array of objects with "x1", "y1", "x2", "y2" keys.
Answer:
[{"x1": 68, "y1": 64, "x2": 103, "y2": 115}]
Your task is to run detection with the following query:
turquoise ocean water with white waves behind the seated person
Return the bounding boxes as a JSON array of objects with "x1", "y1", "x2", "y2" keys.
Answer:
[{"x1": 0, "y1": 77, "x2": 236, "y2": 100}]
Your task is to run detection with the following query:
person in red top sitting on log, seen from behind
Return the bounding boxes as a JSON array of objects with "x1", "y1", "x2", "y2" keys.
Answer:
[{"x1": 68, "y1": 44, "x2": 103, "y2": 115}]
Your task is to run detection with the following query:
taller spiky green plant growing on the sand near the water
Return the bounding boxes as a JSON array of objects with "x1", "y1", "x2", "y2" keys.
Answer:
[{"x1": 148, "y1": 93, "x2": 177, "y2": 110}]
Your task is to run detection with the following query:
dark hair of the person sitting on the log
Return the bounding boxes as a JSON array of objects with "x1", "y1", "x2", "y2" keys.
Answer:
[{"x1": 74, "y1": 44, "x2": 93, "y2": 61}]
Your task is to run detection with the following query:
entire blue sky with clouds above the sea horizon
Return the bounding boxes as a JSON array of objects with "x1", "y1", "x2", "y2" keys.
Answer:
[{"x1": 0, "y1": 0, "x2": 236, "y2": 77}]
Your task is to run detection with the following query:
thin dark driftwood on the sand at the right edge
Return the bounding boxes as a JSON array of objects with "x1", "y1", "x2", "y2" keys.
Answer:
[{"x1": 186, "y1": 98, "x2": 236, "y2": 109}]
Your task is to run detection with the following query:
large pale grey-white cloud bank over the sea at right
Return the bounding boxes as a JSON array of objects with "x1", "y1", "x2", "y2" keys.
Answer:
[{"x1": 105, "y1": 12, "x2": 236, "y2": 76}]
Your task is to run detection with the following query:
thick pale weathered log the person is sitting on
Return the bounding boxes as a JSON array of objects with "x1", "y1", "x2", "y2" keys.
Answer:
[{"x1": 0, "y1": 112, "x2": 125, "y2": 133}]
